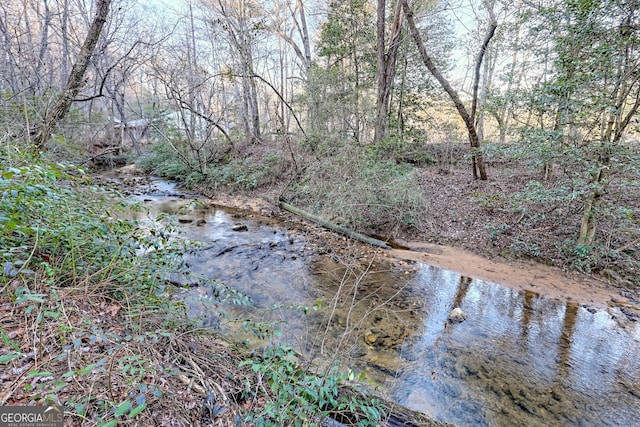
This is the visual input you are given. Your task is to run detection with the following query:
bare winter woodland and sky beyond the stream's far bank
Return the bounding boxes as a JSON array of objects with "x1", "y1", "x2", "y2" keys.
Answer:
[{"x1": 0, "y1": 0, "x2": 640, "y2": 284}]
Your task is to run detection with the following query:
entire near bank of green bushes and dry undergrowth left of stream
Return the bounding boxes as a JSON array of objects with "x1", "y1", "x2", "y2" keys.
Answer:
[{"x1": 0, "y1": 149, "x2": 384, "y2": 426}]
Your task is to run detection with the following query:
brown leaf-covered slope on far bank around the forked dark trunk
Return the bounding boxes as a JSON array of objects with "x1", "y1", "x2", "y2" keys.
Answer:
[{"x1": 412, "y1": 146, "x2": 640, "y2": 289}]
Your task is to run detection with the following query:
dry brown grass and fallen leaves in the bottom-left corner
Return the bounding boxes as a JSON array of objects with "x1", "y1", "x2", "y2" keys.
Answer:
[{"x1": 0, "y1": 290, "x2": 250, "y2": 426}]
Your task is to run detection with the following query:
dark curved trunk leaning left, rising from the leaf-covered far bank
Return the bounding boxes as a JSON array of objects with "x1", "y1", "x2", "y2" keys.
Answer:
[{"x1": 401, "y1": 0, "x2": 488, "y2": 181}]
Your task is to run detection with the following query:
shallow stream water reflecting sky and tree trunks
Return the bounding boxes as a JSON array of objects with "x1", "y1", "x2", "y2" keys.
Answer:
[{"x1": 130, "y1": 180, "x2": 640, "y2": 426}]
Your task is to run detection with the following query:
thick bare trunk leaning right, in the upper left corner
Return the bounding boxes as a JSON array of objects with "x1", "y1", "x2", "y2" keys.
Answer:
[{"x1": 30, "y1": 0, "x2": 111, "y2": 149}]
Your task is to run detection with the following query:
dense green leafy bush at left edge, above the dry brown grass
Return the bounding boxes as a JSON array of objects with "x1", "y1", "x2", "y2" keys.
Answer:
[{"x1": 0, "y1": 148, "x2": 185, "y2": 295}]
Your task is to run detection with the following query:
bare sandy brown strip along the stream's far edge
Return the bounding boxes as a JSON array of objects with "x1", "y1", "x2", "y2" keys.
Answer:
[{"x1": 115, "y1": 165, "x2": 640, "y2": 318}]
